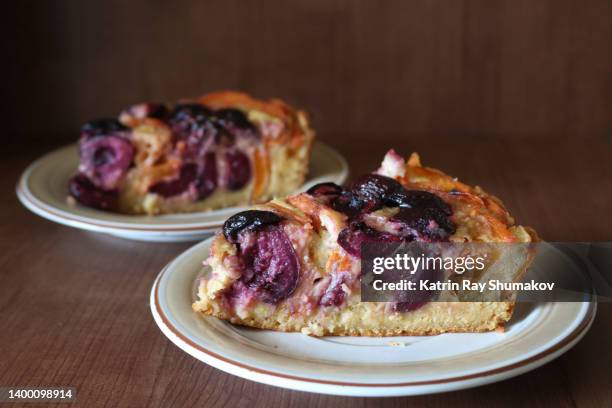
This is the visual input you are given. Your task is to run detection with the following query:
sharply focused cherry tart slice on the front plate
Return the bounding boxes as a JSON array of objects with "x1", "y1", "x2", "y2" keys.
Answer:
[{"x1": 193, "y1": 151, "x2": 537, "y2": 336}]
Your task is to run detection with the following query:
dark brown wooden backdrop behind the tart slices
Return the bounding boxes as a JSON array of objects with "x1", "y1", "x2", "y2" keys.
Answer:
[{"x1": 1, "y1": 0, "x2": 612, "y2": 145}]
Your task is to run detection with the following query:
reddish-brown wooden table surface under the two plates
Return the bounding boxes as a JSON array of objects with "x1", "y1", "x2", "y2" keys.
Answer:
[{"x1": 0, "y1": 139, "x2": 612, "y2": 408}]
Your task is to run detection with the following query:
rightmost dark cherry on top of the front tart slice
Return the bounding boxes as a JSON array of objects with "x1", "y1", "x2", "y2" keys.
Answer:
[{"x1": 391, "y1": 208, "x2": 455, "y2": 242}]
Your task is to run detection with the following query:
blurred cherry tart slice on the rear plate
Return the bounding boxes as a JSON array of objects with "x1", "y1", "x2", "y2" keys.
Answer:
[{"x1": 69, "y1": 92, "x2": 314, "y2": 214}]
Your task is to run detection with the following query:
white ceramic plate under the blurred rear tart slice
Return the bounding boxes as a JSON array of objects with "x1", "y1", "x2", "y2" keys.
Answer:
[{"x1": 17, "y1": 142, "x2": 348, "y2": 242}]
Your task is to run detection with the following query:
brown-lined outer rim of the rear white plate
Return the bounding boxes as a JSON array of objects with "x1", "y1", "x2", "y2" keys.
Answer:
[{"x1": 15, "y1": 140, "x2": 350, "y2": 236}]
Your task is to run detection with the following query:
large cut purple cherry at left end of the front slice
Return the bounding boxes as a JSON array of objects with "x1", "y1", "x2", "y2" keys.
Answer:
[{"x1": 239, "y1": 225, "x2": 300, "y2": 303}]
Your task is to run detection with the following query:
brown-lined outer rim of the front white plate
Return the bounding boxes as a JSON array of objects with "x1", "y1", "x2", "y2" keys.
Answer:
[{"x1": 150, "y1": 237, "x2": 597, "y2": 396}]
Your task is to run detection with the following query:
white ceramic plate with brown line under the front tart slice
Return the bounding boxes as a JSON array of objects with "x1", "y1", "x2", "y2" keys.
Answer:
[{"x1": 151, "y1": 239, "x2": 596, "y2": 396}]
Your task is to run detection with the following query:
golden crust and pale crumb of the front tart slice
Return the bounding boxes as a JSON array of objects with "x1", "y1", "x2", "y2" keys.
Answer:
[{"x1": 193, "y1": 152, "x2": 539, "y2": 336}]
